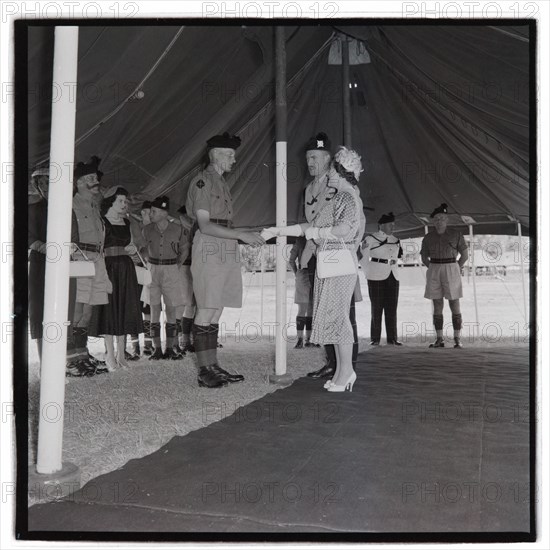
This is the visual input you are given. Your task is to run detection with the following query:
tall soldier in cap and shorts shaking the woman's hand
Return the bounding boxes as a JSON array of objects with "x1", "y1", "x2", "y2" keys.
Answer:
[{"x1": 185, "y1": 132, "x2": 265, "y2": 388}]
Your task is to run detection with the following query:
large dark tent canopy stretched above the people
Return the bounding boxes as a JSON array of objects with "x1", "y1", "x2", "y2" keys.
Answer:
[{"x1": 28, "y1": 21, "x2": 533, "y2": 235}]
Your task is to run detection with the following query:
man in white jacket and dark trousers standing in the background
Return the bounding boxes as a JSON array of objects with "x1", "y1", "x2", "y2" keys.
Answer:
[{"x1": 361, "y1": 212, "x2": 403, "y2": 346}]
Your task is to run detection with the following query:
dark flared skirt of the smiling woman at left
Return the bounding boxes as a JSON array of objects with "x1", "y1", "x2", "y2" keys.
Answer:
[{"x1": 88, "y1": 256, "x2": 143, "y2": 336}]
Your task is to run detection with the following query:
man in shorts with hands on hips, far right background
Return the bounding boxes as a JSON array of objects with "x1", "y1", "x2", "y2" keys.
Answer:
[{"x1": 420, "y1": 203, "x2": 468, "y2": 348}]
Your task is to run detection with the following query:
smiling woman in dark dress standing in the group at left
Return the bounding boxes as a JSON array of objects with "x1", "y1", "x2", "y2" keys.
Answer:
[{"x1": 88, "y1": 187, "x2": 143, "y2": 370}]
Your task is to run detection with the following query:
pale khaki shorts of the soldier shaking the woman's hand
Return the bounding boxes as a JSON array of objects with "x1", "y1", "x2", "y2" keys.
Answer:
[{"x1": 191, "y1": 231, "x2": 243, "y2": 309}]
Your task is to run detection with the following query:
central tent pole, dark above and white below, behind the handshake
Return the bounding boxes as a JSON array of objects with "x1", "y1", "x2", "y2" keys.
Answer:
[{"x1": 275, "y1": 26, "x2": 287, "y2": 376}]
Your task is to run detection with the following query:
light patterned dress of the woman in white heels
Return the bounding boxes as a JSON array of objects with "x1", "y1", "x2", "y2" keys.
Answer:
[{"x1": 311, "y1": 190, "x2": 363, "y2": 344}]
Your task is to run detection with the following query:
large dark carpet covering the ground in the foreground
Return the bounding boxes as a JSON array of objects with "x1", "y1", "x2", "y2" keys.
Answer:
[{"x1": 28, "y1": 346, "x2": 530, "y2": 533}]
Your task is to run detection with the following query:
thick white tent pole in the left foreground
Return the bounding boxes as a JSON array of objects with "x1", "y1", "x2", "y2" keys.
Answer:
[{"x1": 36, "y1": 27, "x2": 78, "y2": 474}]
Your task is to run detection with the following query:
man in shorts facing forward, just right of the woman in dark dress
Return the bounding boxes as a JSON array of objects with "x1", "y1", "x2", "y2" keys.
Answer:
[{"x1": 143, "y1": 196, "x2": 185, "y2": 360}]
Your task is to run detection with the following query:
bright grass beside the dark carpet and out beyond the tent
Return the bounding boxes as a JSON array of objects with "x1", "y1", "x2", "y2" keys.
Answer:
[{"x1": 28, "y1": 268, "x2": 528, "y2": 503}]
